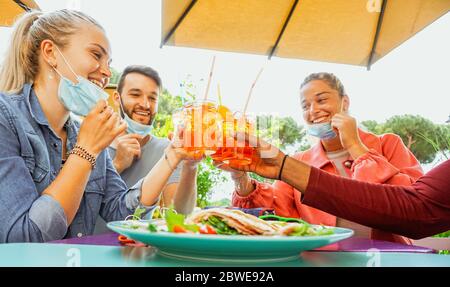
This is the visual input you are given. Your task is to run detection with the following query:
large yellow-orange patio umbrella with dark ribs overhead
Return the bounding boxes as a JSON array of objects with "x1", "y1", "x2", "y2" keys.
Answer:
[{"x1": 161, "y1": 0, "x2": 450, "y2": 69}]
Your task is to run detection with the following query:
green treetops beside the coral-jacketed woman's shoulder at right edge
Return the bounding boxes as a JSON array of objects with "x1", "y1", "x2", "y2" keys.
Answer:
[{"x1": 362, "y1": 115, "x2": 450, "y2": 163}]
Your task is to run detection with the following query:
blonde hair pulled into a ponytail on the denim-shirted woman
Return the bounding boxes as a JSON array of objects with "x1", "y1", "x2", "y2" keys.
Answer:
[{"x1": 0, "y1": 9, "x2": 104, "y2": 93}]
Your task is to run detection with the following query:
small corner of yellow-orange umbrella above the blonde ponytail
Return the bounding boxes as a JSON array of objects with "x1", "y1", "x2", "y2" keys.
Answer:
[{"x1": 0, "y1": 0, "x2": 39, "y2": 26}]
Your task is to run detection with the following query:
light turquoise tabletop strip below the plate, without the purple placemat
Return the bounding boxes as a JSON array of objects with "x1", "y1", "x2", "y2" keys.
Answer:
[{"x1": 0, "y1": 243, "x2": 450, "y2": 267}]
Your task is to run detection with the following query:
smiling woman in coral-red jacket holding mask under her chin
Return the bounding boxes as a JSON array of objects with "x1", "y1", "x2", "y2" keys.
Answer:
[{"x1": 220, "y1": 73, "x2": 423, "y2": 244}]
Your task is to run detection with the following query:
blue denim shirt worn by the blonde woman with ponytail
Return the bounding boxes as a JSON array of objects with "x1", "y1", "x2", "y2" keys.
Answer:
[{"x1": 0, "y1": 84, "x2": 155, "y2": 243}]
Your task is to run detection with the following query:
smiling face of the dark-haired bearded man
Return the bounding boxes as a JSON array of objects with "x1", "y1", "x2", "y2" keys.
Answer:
[{"x1": 114, "y1": 72, "x2": 159, "y2": 125}]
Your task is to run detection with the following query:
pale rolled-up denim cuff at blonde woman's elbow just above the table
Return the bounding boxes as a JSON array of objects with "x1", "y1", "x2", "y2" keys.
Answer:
[{"x1": 29, "y1": 195, "x2": 68, "y2": 241}]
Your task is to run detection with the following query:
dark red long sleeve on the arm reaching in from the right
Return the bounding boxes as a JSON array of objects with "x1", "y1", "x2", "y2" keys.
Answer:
[{"x1": 303, "y1": 160, "x2": 450, "y2": 239}]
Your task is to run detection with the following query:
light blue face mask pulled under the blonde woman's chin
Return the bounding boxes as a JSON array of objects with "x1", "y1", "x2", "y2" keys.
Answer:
[{"x1": 54, "y1": 47, "x2": 109, "y2": 117}]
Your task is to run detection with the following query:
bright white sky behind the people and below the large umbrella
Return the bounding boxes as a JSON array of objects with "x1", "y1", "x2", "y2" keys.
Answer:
[{"x1": 0, "y1": 0, "x2": 450, "y2": 200}]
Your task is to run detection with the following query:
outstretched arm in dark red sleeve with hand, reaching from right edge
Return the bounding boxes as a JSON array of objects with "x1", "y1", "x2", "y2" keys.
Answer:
[{"x1": 231, "y1": 135, "x2": 450, "y2": 239}]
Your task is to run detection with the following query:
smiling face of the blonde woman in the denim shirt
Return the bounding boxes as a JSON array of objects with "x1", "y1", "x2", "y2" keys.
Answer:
[{"x1": 54, "y1": 23, "x2": 111, "y2": 88}]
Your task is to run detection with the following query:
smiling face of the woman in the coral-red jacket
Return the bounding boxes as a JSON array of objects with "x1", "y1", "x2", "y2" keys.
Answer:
[{"x1": 300, "y1": 80, "x2": 349, "y2": 124}]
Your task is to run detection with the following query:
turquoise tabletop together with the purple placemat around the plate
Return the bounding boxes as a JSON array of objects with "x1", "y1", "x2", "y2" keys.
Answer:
[{"x1": 0, "y1": 233, "x2": 450, "y2": 267}]
